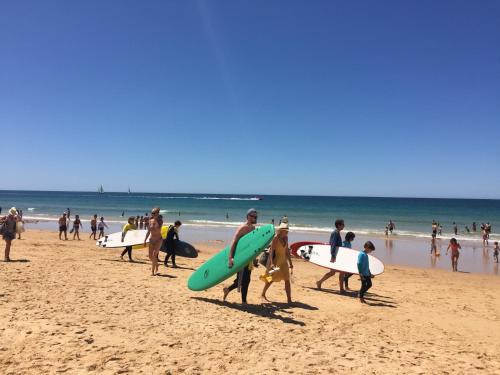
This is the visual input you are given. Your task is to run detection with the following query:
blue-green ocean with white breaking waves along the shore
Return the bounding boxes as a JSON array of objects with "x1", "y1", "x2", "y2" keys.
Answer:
[{"x1": 0, "y1": 190, "x2": 500, "y2": 244}]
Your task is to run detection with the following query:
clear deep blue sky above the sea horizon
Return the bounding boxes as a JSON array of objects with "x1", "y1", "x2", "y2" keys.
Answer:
[{"x1": 0, "y1": 0, "x2": 500, "y2": 198}]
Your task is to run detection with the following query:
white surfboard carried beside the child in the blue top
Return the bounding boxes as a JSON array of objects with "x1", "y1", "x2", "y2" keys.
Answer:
[{"x1": 297, "y1": 245, "x2": 384, "y2": 275}]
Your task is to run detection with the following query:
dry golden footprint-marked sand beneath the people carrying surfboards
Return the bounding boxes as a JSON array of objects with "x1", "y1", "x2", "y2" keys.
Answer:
[{"x1": 0, "y1": 231, "x2": 500, "y2": 375}]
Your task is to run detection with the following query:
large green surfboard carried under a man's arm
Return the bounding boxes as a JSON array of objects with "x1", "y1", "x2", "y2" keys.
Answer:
[{"x1": 188, "y1": 224, "x2": 274, "y2": 291}]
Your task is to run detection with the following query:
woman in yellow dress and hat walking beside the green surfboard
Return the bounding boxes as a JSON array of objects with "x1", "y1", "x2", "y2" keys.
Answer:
[{"x1": 260, "y1": 221, "x2": 293, "y2": 303}]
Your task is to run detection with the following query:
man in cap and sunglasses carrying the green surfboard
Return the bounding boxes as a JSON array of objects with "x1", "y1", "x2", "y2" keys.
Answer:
[{"x1": 223, "y1": 208, "x2": 257, "y2": 304}]
